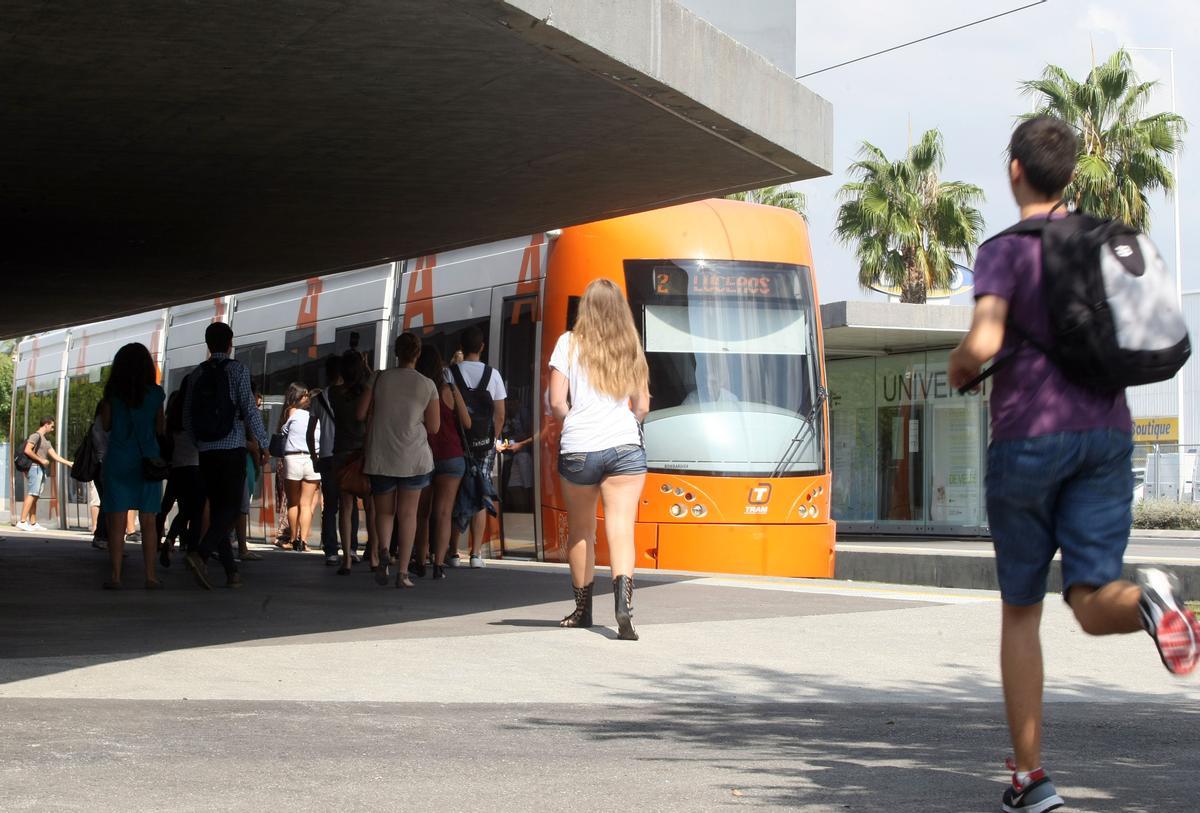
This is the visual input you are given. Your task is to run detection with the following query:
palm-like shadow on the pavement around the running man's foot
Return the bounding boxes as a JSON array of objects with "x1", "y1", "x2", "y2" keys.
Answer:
[{"x1": 512, "y1": 666, "x2": 1200, "y2": 813}]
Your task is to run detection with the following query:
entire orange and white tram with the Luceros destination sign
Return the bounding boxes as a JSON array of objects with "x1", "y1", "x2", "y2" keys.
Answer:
[{"x1": 7, "y1": 200, "x2": 834, "y2": 577}]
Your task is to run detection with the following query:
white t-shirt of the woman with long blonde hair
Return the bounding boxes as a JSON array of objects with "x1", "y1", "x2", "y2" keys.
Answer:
[{"x1": 550, "y1": 331, "x2": 642, "y2": 452}]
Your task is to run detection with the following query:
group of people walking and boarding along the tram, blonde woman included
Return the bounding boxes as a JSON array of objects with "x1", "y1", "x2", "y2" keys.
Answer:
[{"x1": 18, "y1": 286, "x2": 649, "y2": 640}]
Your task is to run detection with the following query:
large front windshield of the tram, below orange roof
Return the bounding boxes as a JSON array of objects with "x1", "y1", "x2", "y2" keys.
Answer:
[{"x1": 625, "y1": 260, "x2": 824, "y2": 476}]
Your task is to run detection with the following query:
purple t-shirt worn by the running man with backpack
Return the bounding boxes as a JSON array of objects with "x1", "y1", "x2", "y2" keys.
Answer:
[{"x1": 974, "y1": 217, "x2": 1133, "y2": 440}]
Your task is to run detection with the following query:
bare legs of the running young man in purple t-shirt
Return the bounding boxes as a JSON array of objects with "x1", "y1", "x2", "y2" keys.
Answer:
[{"x1": 1000, "y1": 582, "x2": 1141, "y2": 771}]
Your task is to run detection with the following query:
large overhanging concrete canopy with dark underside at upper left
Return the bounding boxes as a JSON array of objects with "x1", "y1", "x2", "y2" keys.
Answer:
[{"x1": 0, "y1": 0, "x2": 832, "y2": 336}]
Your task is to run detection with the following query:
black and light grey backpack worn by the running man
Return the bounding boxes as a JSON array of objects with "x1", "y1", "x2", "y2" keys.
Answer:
[{"x1": 964, "y1": 212, "x2": 1192, "y2": 392}]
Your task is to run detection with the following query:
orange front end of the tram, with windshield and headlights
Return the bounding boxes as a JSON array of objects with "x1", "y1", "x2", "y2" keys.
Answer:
[{"x1": 540, "y1": 200, "x2": 835, "y2": 577}]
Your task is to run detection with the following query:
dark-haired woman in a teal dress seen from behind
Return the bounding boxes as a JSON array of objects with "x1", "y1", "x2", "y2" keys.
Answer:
[{"x1": 100, "y1": 343, "x2": 166, "y2": 590}]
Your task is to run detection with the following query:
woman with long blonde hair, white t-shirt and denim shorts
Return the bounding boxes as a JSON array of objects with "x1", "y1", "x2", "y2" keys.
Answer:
[{"x1": 550, "y1": 279, "x2": 650, "y2": 640}]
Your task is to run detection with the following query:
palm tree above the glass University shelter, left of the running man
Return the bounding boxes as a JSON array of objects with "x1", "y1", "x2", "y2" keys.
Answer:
[{"x1": 834, "y1": 130, "x2": 984, "y2": 303}]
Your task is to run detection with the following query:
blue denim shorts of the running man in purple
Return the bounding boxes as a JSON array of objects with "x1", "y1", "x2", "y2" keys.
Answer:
[{"x1": 986, "y1": 429, "x2": 1133, "y2": 606}]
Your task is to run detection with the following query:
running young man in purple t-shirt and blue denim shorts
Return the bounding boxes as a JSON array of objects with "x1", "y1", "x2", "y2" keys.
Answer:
[{"x1": 949, "y1": 118, "x2": 1200, "y2": 813}]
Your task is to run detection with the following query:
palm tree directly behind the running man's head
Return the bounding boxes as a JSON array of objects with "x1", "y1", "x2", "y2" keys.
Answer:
[{"x1": 1021, "y1": 49, "x2": 1187, "y2": 231}]
